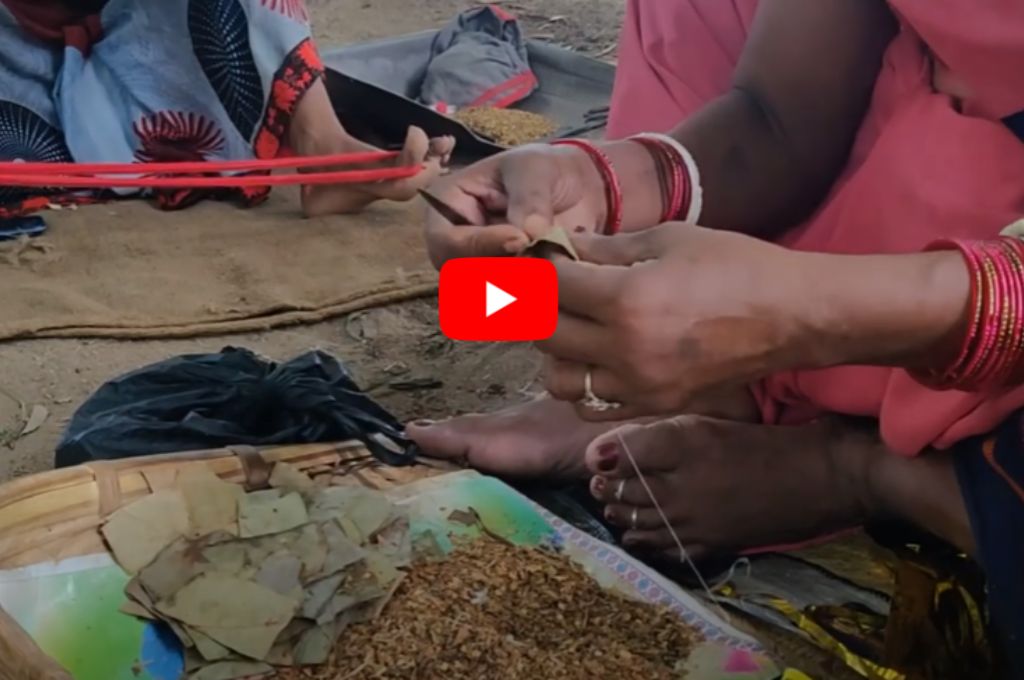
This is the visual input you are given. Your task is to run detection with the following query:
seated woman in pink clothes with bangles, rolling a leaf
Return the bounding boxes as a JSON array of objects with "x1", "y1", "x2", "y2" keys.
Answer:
[{"x1": 409, "y1": 0, "x2": 1024, "y2": 677}]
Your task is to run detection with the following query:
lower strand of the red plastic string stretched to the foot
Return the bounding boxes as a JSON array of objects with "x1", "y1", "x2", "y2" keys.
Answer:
[{"x1": 0, "y1": 166, "x2": 421, "y2": 188}]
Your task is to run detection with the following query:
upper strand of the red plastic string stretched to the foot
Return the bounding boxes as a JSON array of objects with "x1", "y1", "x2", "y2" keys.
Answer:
[{"x1": 0, "y1": 151, "x2": 399, "y2": 175}]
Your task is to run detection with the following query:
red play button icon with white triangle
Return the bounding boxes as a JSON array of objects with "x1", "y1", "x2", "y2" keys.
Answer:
[{"x1": 439, "y1": 257, "x2": 558, "y2": 342}]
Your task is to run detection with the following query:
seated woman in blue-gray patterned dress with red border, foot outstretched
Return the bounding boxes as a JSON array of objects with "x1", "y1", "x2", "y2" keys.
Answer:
[{"x1": 0, "y1": 0, "x2": 454, "y2": 217}]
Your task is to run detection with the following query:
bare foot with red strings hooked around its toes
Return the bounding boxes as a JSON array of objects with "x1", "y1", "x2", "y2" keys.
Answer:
[{"x1": 302, "y1": 127, "x2": 455, "y2": 217}]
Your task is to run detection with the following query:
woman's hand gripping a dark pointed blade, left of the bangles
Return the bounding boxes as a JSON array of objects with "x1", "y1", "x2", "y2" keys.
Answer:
[{"x1": 426, "y1": 144, "x2": 606, "y2": 268}]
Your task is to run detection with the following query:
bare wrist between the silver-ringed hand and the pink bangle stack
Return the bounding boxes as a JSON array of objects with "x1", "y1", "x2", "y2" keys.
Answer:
[{"x1": 805, "y1": 252, "x2": 971, "y2": 368}]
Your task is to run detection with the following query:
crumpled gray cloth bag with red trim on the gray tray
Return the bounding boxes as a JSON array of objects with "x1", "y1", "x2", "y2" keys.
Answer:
[{"x1": 420, "y1": 5, "x2": 538, "y2": 110}]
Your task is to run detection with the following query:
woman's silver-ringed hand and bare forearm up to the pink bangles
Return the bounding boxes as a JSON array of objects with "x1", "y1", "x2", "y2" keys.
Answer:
[{"x1": 538, "y1": 223, "x2": 969, "y2": 420}]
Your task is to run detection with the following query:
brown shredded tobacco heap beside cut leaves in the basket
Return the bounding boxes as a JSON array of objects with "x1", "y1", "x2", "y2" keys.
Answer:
[{"x1": 276, "y1": 539, "x2": 698, "y2": 680}]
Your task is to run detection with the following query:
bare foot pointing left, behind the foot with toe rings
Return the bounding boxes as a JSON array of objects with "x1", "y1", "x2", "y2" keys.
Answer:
[{"x1": 406, "y1": 397, "x2": 618, "y2": 479}]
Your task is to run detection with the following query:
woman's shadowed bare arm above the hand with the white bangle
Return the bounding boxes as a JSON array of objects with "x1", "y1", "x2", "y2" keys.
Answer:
[{"x1": 593, "y1": 0, "x2": 896, "y2": 238}]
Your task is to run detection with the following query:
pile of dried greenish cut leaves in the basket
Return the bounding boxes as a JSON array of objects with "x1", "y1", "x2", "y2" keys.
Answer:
[{"x1": 103, "y1": 463, "x2": 412, "y2": 680}]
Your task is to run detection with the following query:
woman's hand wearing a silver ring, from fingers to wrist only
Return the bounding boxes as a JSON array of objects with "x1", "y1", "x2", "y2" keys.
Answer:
[{"x1": 538, "y1": 222, "x2": 812, "y2": 420}]
